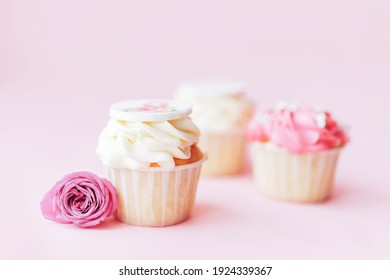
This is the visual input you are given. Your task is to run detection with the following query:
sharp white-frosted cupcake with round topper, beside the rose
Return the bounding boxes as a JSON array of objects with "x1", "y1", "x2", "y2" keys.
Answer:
[{"x1": 97, "y1": 100, "x2": 205, "y2": 227}]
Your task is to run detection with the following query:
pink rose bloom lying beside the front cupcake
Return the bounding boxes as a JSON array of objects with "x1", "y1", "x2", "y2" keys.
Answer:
[{"x1": 41, "y1": 172, "x2": 118, "y2": 227}]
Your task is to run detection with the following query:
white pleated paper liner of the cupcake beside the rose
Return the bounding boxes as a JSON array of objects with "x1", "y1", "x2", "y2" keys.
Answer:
[{"x1": 105, "y1": 158, "x2": 205, "y2": 227}]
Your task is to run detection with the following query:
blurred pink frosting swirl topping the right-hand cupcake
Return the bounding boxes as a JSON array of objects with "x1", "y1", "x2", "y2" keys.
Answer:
[{"x1": 247, "y1": 105, "x2": 349, "y2": 153}]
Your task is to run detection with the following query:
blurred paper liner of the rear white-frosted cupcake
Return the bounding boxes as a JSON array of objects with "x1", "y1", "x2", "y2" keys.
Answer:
[{"x1": 199, "y1": 131, "x2": 246, "y2": 175}]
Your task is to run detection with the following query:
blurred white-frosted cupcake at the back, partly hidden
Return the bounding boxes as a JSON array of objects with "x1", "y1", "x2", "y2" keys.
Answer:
[{"x1": 175, "y1": 82, "x2": 253, "y2": 175}]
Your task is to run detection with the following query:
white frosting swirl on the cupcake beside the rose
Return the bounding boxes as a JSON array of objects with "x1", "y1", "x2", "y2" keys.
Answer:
[{"x1": 96, "y1": 117, "x2": 200, "y2": 169}]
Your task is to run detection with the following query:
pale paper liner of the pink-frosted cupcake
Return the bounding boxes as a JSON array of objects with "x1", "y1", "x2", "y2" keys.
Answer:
[{"x1": 250, "y1": 142, "x2": 341, "y2": 202}]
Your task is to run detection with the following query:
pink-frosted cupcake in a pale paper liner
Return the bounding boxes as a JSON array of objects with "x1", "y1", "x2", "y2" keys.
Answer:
[{"x1": 247, "y1": 106, "x2": 348, "y2": 202}]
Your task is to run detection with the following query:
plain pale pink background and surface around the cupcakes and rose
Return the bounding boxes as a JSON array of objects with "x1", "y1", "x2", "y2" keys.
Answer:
[{"x1": 0, "y1": 0, "x2": 390, "y2": 259}]
